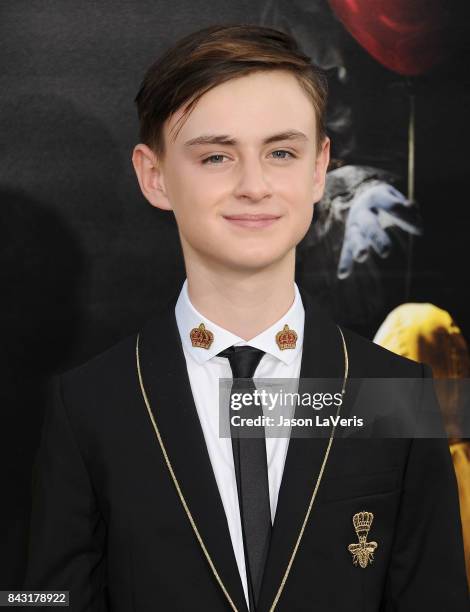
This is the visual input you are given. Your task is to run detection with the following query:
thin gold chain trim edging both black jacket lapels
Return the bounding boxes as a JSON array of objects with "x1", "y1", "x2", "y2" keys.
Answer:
[{"x1": 135, "y1": 325, "x2": 349, "y2": 612}]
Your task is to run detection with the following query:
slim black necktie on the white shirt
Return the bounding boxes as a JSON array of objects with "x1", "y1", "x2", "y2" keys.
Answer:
[{"x1": 218, "y1": 346, "x2": 271, "y2": 612}]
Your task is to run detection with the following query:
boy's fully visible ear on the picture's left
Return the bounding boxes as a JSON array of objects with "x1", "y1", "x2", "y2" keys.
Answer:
[{"x1": 132, "y1": 143, "x2": 172, "y2": 210}]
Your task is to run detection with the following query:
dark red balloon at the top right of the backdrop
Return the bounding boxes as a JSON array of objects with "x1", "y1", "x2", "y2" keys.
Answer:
[{"x1": 329, "y1": 0, "x2": 448, "y2": 76}]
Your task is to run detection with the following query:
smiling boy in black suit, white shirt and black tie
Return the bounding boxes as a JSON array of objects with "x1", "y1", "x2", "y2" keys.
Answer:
[{"x1": 24, "y1": 25, "x2": 468, "y2": 612}]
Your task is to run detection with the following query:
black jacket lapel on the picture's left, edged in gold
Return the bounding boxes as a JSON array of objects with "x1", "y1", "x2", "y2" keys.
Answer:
[{"x1": 139, "y1": 292, "x2": 247, "y2": 612}]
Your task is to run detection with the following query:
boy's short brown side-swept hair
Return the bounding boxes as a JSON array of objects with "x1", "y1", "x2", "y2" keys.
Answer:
[{"x1": 135, "y1": 24, "x2": 328, "y2": 157}]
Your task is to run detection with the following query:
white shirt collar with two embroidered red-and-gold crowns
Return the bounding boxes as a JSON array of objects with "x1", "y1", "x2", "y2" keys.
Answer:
[{"x1": 175, "y1": 279, "x2": 305, "y2": 365}]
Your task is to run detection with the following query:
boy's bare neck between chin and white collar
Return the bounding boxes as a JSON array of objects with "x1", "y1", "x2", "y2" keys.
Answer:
[{"x1": 186, "y1": 249, "x2": 295, "y2": 341}]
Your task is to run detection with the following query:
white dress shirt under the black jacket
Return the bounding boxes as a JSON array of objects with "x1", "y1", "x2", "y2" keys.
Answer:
[{"x1": 175, "y1": 279, "x2": 305, "y2": 604}]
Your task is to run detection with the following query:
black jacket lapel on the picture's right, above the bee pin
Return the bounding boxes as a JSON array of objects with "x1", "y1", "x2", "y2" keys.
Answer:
[{"x1": 257, "y1": 287, "x2": 344, "y2": 612}]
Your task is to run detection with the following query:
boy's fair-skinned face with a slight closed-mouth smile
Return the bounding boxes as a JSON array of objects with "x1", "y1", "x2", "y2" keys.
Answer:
[{"x1": 133, "y1": 70, "x2": 329, "y2": 271}]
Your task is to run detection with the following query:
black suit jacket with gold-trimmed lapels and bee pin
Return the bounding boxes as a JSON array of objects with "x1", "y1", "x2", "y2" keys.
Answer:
[{"x1": 23, "y1": 289, "x2": 469, "y2": 612}]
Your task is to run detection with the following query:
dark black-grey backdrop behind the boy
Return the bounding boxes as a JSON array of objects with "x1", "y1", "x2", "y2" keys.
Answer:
[{"x1": 0, "y1": 0, "x2": 470, "y2": 589}]
